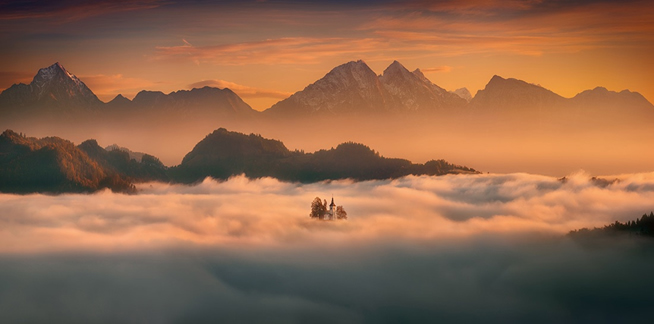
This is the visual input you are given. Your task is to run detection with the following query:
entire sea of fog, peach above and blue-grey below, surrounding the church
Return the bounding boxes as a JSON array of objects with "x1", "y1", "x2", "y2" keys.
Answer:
[{"x1": 0, "y1": 173, "x2": 654, "y2": 323}]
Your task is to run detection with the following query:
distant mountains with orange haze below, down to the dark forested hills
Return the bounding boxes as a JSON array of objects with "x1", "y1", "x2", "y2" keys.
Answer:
[{"x1": 0, "y1": 60, "x2": 654, "y2": 176}]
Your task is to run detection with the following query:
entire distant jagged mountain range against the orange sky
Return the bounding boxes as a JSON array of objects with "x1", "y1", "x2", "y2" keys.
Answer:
[{"x1": 0, "y1": 60, "x2": 654, "y2": 119}]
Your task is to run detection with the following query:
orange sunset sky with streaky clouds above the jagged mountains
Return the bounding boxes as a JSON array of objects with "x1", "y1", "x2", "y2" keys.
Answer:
[{"x1": 0, "y1": 0, "x2": 654, "y2": 110}]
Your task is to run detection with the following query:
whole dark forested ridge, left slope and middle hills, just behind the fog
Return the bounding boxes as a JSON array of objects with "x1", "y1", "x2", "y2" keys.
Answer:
[{"x1": 0, "y1": 128, "x2": 477, "y2": 193}]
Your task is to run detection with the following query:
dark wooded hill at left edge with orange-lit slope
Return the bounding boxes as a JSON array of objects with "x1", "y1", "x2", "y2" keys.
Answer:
[{"x1": 0, "y1": 130, "x2": 167, "y2": 193}]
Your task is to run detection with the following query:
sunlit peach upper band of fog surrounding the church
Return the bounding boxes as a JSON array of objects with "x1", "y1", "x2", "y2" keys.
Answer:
[{"x1": 0, "y1": 173, "x2": 654, "y2": 253}]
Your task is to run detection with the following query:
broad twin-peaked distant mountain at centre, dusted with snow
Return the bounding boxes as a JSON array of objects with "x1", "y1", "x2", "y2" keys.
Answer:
[{"x1": 264, "y1": 60, "x2": 466, "y2": 117}]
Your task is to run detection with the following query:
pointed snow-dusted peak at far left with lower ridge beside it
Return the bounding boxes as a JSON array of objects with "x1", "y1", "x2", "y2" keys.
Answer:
[{"x1": 0, "y1": 63, "x2": 258, "y2": 120}]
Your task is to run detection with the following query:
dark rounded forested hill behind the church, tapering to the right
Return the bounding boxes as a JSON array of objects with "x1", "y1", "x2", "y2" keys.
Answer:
[{"x1": 169, "y1": 128, "x2": 476, "y2": 183}]
